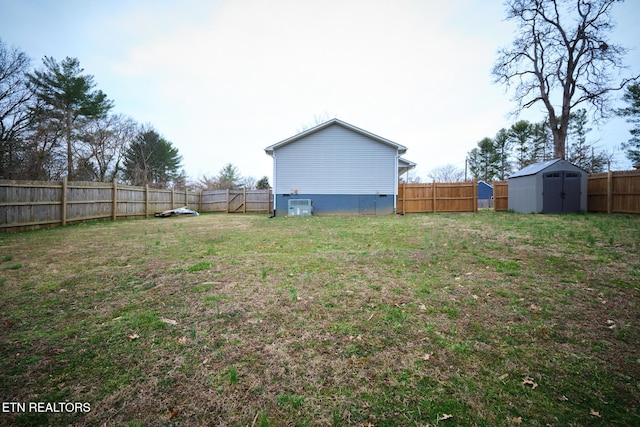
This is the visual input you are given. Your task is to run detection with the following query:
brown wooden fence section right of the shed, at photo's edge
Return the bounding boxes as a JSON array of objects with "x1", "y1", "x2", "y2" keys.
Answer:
[{"x1": 587, "y1": 170, "x2": 640, "y2": 213}]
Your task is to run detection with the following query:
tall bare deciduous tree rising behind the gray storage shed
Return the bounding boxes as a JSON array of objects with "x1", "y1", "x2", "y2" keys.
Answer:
[{"x1": 493, "y1": 0, "x2": 640, "y2": 158}]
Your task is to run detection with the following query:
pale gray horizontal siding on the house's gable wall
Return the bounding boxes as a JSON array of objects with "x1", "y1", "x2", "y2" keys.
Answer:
[{"x1": 274, "y1": 126, "x2": 398, "y2": 195}]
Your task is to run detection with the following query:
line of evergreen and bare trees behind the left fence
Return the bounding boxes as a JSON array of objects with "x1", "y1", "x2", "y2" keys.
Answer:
[{"x1": 0, "y1": 39, "x2": 269, "y2": 189}]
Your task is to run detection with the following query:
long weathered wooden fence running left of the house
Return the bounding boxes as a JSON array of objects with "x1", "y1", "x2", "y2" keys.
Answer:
[{"x1": 0, "y1": 179, "x2": 271, "y2": 231}]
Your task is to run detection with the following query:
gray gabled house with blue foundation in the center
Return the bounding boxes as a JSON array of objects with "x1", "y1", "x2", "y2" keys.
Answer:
[{"x1": 265, "y1": 119, "x2": 415, "y2": 216}]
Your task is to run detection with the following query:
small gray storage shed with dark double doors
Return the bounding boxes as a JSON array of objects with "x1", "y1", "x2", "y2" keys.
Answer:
[{"x1": 508, "y1": 159, "x2": 587, "y2": 213}]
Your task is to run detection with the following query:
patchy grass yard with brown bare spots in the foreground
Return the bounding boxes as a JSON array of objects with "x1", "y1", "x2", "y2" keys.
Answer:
[{"x1": 0, "y1": 212, "x2": 640, "y2": 426}]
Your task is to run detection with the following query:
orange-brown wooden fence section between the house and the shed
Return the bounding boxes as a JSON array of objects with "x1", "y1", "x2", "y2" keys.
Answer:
[{"x1": 397, "y1": 181, "x2": 478, "y2": 213}]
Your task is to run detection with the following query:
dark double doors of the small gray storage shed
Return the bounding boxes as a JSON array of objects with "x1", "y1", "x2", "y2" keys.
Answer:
[{"x1": 542, "y1": 171, "x2": 582, "y2": 213}]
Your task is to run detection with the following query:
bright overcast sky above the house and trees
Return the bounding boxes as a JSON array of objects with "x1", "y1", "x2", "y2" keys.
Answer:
[{"x1": 0, "y1": 0, "x2": 640, "y2": 182}]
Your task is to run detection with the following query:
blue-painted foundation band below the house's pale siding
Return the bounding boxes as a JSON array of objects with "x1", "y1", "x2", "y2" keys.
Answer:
[{"x1": 275, "y1": 194, "x2": 395, "y2": 216}]
